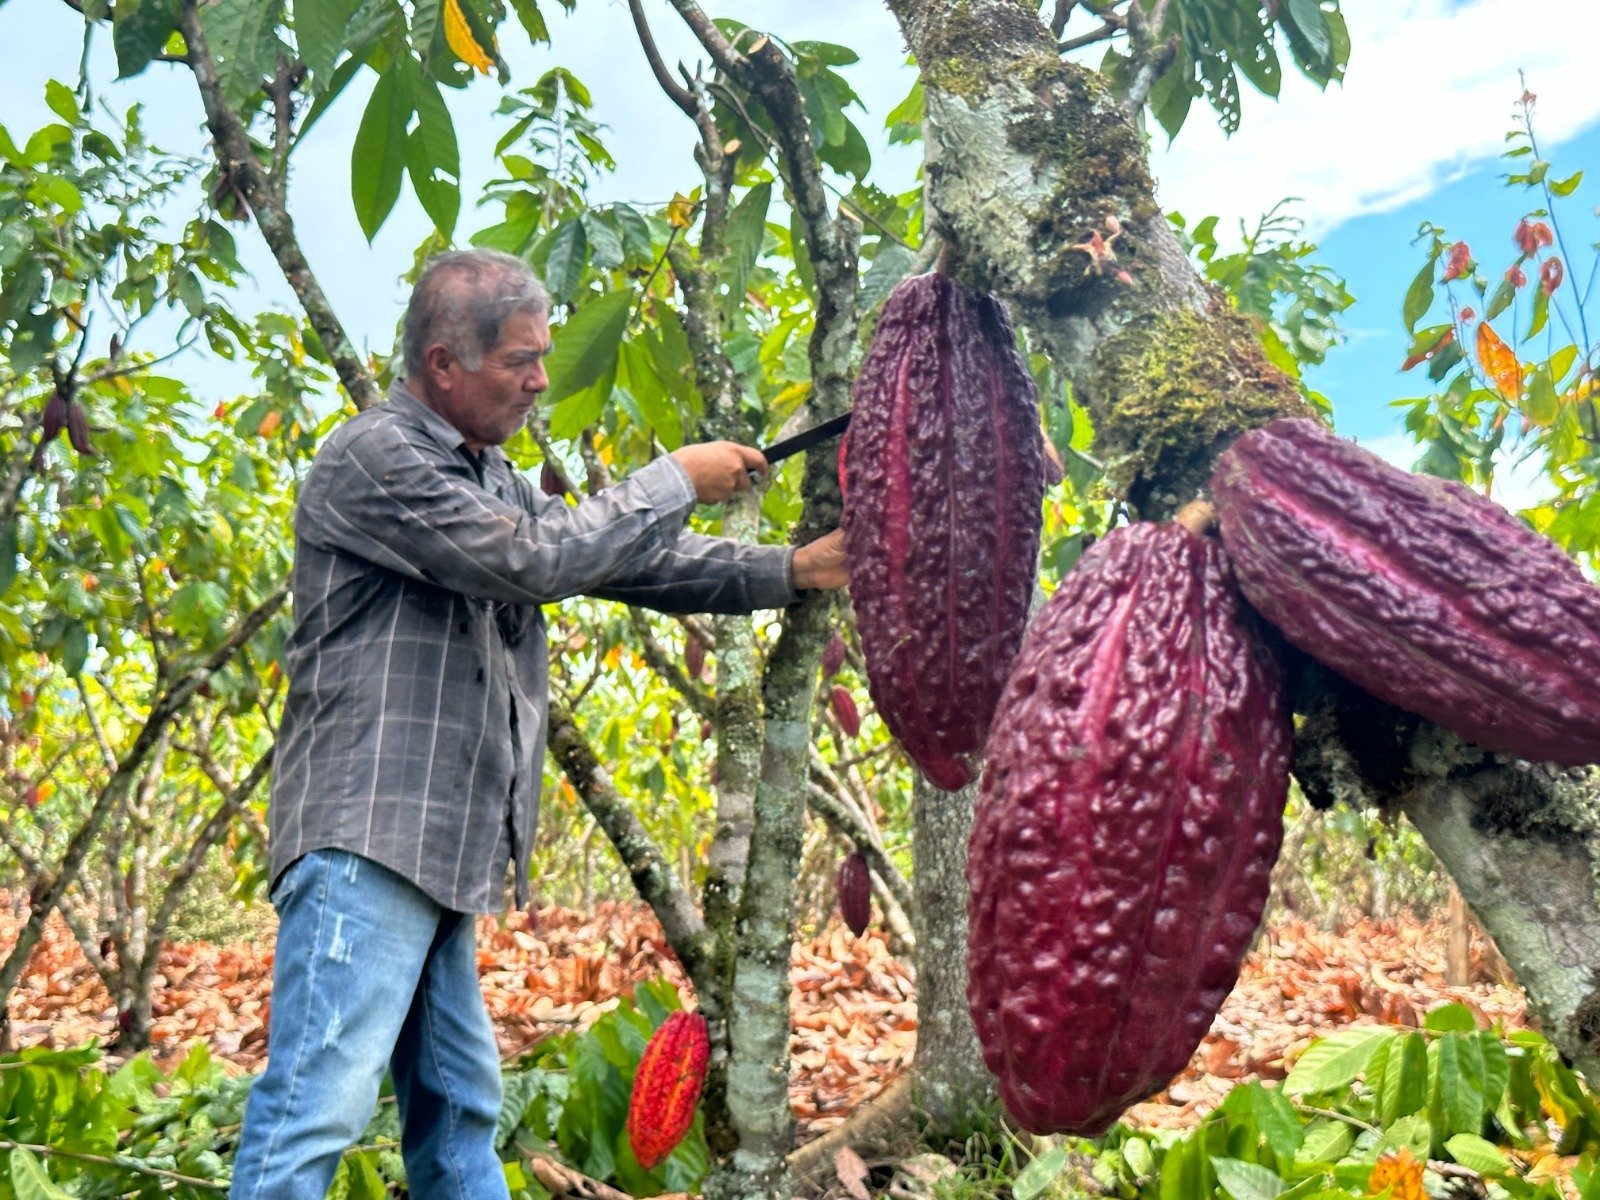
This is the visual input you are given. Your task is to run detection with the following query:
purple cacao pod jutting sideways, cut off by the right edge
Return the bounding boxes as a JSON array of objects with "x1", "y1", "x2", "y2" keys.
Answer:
[{"x1": 1211, "y1": 421, "x2": 1600, "y2": 766}]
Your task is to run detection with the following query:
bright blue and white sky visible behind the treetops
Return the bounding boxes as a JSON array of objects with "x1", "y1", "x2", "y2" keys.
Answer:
[{"x1": 0, "y1": 0, "x2": 1600, "y2": 483}]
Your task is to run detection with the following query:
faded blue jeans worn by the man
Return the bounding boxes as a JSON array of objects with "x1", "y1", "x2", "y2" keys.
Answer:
[{"x1": 229, "y1": 850, "x2": 509, "y2": 1200}]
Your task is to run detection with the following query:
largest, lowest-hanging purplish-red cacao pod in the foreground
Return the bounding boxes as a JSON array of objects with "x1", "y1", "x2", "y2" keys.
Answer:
[{"x1": 966, "y1": 523, "x2": 1291, "y2": 1134}]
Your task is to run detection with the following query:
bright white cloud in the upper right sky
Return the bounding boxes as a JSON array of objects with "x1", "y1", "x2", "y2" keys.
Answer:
[{"x1": 1154, "y1": 0, "x2": 1600, "y2": 237}]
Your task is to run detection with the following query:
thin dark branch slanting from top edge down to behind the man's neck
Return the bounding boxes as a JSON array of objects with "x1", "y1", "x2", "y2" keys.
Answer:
[{"x1": 178, "y1": 0, "x2": 382, "y2": 408}]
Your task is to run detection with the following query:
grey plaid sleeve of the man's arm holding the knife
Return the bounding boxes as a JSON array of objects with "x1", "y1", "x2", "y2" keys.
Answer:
[{"x1": 296, "y1": 422, "x2": 694, "y2": 605}]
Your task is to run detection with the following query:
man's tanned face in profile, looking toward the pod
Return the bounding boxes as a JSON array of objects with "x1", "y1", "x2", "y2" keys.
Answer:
[{"x1": 424, "y1": 312, "x2": 550, "y2": 451}]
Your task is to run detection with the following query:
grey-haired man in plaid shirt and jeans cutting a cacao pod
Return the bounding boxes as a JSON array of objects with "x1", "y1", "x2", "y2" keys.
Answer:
[{"x1": 230, "y1": 250, "x2": 846, "y2": 1200}]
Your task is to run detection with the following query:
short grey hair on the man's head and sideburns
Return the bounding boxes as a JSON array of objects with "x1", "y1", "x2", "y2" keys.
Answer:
[{"x1": 402, "y1": 250, "x2": 550, "y2": 376}]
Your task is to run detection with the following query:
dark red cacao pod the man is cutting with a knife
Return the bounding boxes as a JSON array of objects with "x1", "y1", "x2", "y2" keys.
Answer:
[{"x1": 840, "y1": 274, "x2": 1045, "y2": 790}]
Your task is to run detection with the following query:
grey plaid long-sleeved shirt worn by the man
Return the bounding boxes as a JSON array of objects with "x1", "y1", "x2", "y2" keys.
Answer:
[{"x1": 269, "y1": 382, "x2": 797, "y2": 912}]
